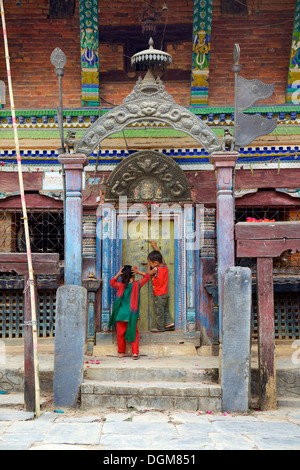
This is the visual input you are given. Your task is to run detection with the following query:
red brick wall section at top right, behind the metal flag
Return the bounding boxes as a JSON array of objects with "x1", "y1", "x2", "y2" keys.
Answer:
[{"x1": 209, "y1": 0, "x2": 295, "y2": 106}]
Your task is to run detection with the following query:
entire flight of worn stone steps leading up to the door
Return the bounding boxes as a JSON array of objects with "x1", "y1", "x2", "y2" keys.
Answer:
[{"x1": 81, "y1": 332, "x2": 221, "y2": 411}]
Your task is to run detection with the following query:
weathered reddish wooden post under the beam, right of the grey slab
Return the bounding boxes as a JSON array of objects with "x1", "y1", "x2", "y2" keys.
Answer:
[{"x1": 256, "y1": 258, "x2": 277, "y2": 411}]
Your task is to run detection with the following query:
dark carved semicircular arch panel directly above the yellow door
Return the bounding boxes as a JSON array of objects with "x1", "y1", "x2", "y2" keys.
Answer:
[{"x1": 105, "y1": 150, "x2": 191, "y2": 203}]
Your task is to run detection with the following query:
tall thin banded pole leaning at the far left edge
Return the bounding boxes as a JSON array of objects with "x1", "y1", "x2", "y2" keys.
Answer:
[{"x1": 0, "y1": 0, "x2": 40, "y2": 417}]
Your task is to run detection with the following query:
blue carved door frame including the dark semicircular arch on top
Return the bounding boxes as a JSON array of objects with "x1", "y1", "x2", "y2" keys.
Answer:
[{"x1": 97, "y1": 151, "x2": 199, "y2": 331}]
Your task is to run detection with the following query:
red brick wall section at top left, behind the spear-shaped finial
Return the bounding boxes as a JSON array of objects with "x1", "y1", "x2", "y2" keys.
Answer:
[{"x1": 0, "y1": 0, "x2": 81, "y2": 109}]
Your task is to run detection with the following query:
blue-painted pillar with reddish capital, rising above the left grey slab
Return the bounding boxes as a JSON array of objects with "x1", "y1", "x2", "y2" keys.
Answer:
[{"x1": 58, "y1": 153, "x2": 88, "y2": 286}]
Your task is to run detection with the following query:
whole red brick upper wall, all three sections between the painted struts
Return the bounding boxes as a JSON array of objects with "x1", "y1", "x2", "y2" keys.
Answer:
[{"x1": 0, "y1": 0, "x2": 295, "y2": 108}]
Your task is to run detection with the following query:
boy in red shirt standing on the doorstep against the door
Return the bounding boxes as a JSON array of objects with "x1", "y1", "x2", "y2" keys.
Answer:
[{"x1": 148, "y1": 241, "x2": 175, "y2": 333}]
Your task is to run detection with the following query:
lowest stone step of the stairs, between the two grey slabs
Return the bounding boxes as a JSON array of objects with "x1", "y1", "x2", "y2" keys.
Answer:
[{"x1": 81, "y1": 380, "x2": 221, "y2": 411}]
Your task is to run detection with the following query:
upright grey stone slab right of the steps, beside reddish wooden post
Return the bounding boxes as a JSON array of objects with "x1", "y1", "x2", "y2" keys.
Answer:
[{"x1": 222, "y1": 267, "x2": 252, "y2": 413}]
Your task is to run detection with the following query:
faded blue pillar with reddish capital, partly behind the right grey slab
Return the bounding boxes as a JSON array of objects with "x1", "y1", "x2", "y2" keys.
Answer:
[{"x1": 210, "y1": 151, "x2": 239, "y2": 339}]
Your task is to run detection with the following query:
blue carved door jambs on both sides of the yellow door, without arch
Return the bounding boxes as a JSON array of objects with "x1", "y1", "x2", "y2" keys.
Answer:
[{"x1": 97, "y1": 203, "x2": 199, "y2": 331}]
